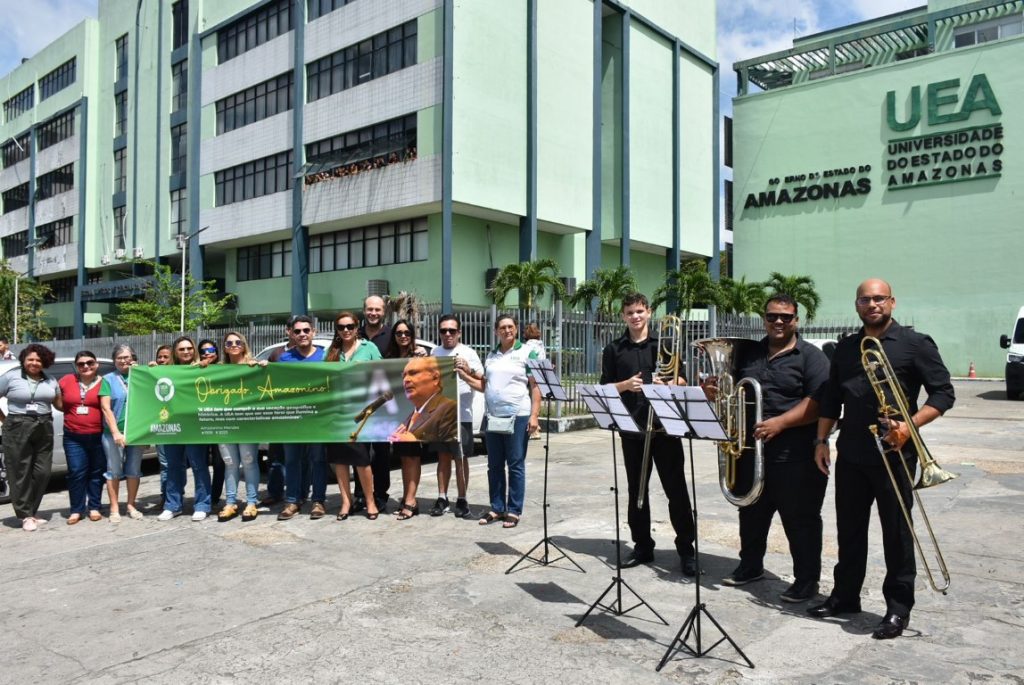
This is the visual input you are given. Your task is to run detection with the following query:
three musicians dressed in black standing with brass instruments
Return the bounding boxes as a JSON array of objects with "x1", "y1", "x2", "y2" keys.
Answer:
[{"x1": 601, "y1": 279, "x2": 954, "y2": 640}]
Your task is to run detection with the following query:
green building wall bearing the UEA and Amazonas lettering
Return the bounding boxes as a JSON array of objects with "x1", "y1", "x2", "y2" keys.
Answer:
[{"x1": 733, "y1": 1, "x2": 1024, "y2": 376}]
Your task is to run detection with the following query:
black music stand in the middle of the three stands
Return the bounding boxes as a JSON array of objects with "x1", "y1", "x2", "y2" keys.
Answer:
[{"x1": 577, "y1": 385, "x2": 669, "y2": 628}]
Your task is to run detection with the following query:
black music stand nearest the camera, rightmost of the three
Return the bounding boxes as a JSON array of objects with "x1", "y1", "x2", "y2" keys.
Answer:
[{"x1": 643, "y1": 385, "x2": 754, "y2": 671}]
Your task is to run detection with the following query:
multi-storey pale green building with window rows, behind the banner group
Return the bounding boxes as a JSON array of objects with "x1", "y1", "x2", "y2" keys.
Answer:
[{"x1": 0, "y1": 0, "x2": 719, "y2": 336}]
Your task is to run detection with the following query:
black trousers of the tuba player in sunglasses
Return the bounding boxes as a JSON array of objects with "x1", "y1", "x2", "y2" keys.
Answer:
[{"x1": 739, "y1": 456, "x2": 828, "y2": 583}]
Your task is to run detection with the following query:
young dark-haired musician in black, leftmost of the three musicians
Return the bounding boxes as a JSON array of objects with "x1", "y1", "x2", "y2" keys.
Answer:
[{"x1": 601, "y1": 293, "x2": 696, "y2": 575}]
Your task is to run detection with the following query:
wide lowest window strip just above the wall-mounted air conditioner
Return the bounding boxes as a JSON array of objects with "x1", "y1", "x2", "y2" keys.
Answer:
[{"x1": 309, "y1": 218, "x2": 429, "y2": 273}]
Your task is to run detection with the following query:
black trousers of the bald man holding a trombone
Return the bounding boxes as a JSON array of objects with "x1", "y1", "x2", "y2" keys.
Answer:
[{"x1": 831, "y1": 450, "x2": 918, "y2": 617}]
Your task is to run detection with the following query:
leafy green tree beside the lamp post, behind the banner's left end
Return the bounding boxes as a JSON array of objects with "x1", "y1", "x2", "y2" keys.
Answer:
[{"x1": 114, "y1": 261, "x2": 231, "y2": 335}]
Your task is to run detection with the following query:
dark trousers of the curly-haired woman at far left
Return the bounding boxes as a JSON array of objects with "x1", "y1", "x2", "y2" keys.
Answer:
[{"x1": 3, "y1": 414, "x2": 53, "y2": 518}]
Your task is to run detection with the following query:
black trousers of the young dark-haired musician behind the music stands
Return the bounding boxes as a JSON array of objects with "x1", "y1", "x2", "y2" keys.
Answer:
[{"x1": 622, "y1": 433, "x2": 693, "y2": 557}]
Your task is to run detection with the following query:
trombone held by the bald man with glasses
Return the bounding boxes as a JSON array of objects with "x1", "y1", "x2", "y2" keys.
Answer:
[{"x1": 860, "y1": 336, "x2": 956, "y2": 595}]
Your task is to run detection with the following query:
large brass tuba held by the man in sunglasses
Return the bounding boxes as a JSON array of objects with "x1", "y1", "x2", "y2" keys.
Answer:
[{"x1": 693, "y1": 338, "x2": 765, "y2": 507}]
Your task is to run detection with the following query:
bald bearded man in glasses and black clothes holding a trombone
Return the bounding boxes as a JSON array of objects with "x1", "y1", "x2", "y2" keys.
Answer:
[{"x1": 808, "y1": 279, "x2": 954, "y2": 640}]
